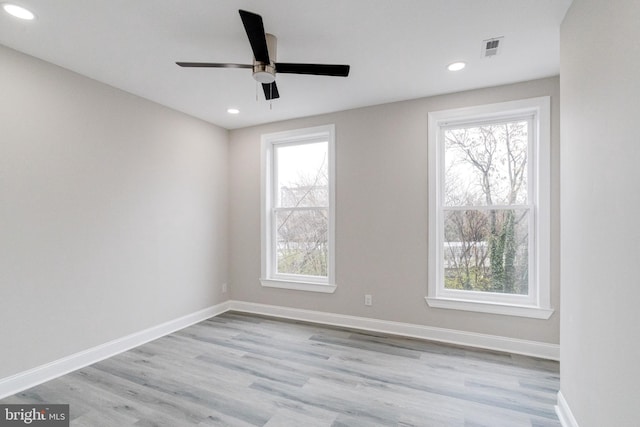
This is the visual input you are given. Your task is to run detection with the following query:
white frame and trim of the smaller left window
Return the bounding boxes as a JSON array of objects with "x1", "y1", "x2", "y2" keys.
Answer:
[{"x1": 260, "y1": 125, "x2": 336, "y2": 293}]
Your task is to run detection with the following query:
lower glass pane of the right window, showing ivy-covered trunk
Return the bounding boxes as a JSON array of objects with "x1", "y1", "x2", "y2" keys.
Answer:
[{"x1": 443, "y1": 209, "x2": 529, "y2": 295}]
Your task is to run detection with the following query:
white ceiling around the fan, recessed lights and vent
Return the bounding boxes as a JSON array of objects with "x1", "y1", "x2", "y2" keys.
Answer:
[{"x1": 0, "y1": 0, "x2": 571, "y2": 129}]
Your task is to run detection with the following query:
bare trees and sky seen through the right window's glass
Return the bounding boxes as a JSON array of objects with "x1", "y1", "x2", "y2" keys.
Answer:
[{"x1": 443, "y1": 120, "x2": 531, "y2": 295}]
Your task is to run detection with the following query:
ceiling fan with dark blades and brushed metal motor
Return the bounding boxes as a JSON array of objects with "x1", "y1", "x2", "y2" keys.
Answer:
[{"x1": 176, "y1": 10, "x2": 350, "y2": 100}]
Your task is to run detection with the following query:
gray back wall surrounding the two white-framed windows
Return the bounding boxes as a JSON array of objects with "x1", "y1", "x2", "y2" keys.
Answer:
[{"x1": 229, "y1": 77, "x2": 560, "y2": 343}]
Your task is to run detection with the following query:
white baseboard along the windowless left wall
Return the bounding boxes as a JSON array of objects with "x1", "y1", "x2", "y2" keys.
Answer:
[{"x1": 0, "y1": 301, "x2": 229, "y2": 399}]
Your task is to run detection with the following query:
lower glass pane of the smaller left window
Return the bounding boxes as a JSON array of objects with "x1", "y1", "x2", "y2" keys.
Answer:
[{"x1": 275, "y1": 209, "x2": 329, "y2": 277}]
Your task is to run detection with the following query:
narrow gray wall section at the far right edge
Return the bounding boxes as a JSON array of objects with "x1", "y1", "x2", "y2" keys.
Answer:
[{"x1": 560, "y1": 0, "x2": 640, "y2": 427}]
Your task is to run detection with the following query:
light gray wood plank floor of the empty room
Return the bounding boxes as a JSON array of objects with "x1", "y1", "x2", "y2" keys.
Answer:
[{"x1": 2, "y1": 313, "x2": 560, "y2": 427}]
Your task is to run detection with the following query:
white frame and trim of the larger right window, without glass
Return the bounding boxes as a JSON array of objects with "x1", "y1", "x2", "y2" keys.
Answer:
[{"x1": 425, "y1": 96, "x2": 553, "y2": 319}]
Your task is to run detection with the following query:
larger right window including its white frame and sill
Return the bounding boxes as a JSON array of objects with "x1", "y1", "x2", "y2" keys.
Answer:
[{"x1": 427, "y1": 97, "x2": 553, "y2": 318}]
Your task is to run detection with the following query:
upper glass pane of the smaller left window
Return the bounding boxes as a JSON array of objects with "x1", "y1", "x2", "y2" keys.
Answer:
[{"x1": 275, "y1": 142, "x2": 329, "y2": 207}]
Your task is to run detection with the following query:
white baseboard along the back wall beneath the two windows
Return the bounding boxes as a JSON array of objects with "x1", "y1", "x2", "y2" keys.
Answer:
[{"x1": 229, "y1": 301, "x2": 560, "y2": 360}]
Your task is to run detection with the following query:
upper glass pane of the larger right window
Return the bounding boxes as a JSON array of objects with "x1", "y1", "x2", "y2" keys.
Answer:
[{"x1": 444, "y1": 120, "x2": 528, "y2": 206}]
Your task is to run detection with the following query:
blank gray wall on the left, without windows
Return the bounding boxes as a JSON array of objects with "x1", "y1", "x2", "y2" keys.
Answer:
[{"x1": 0, "y1": 46, "x2": 228, "y2": 378}]
